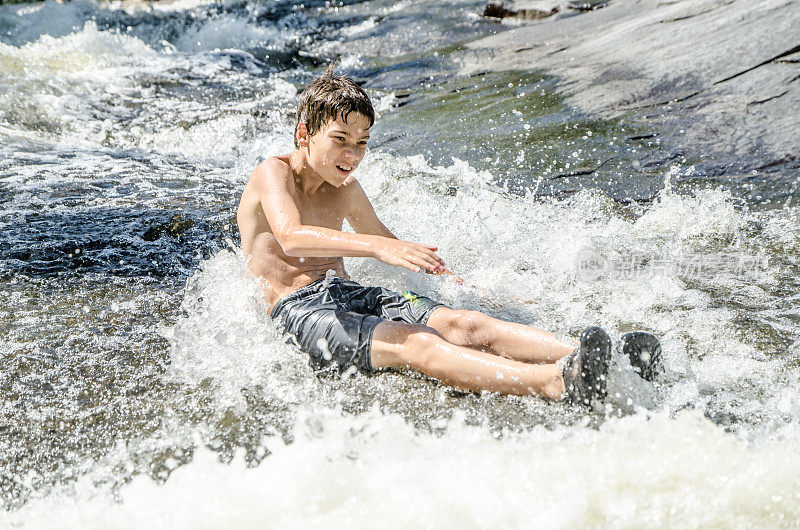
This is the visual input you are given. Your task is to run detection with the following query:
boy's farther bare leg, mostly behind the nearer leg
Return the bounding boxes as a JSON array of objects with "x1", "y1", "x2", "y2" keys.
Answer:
[{"x1": 427, "y1": 307, "x2": 578, "y2": 363}]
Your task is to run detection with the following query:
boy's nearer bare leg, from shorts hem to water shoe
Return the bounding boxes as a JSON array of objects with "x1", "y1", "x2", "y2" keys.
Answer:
[{"x1": 370, "y1": 316, "x2": 565, "y2": 399}]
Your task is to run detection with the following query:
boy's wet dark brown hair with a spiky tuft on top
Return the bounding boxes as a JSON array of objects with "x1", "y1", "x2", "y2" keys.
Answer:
[{"x1": 294, "y1": 61, "x2": 375, "y2": 147}]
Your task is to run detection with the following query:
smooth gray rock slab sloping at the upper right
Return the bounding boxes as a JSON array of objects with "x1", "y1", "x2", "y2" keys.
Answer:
[{"x1": 462, "y1": 0, "x2": 800, "y2": 173}]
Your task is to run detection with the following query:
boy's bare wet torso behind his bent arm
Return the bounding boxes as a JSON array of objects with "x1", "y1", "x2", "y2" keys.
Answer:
[{"x1": 236, "y1": 155, "x2": 348, "y2": 309}]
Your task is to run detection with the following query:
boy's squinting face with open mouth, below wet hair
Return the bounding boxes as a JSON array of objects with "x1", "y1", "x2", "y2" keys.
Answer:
[{"x1": 308, "y1": 112, "x2": 369, "y2": 187}]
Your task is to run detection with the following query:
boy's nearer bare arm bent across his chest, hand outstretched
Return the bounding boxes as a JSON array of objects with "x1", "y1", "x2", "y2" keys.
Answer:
[{"x1": 253, "y1": 158, "x2": 440, "y2": 272}]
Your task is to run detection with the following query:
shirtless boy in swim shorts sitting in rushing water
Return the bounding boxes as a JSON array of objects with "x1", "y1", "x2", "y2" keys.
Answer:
[{"x1": 237, "y1": 65, "x2": 660, "y2": 404}]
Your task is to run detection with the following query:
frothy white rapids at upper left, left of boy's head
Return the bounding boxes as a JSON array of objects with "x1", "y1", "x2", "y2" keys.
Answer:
[{"x1": 0, "y1": 16, "x2": 296, "y2": 165}]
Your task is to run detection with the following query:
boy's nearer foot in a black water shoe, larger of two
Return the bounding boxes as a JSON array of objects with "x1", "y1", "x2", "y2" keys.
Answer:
[{"x1": 559, "y1": 326, "x2": 611, "y2": 405}]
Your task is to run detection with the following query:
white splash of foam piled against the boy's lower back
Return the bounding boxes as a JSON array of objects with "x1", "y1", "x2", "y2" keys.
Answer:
[{"x1": 166, "y1": 251, "x2": 317, "y2": 405}]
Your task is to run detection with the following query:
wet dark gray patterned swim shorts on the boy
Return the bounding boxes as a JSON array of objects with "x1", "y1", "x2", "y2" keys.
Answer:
[{"x1": 270, "y1": 278, "x2": 444, "y2": 373}]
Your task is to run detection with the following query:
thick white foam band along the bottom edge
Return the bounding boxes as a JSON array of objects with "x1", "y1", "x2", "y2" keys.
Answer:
[{"x1": 3, "y1": 410, "x2": 800, "y2": 528}]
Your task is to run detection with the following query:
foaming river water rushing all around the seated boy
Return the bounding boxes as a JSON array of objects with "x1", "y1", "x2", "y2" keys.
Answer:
[{"x1": 0, "y1": 0, "x2": 800, "y2": 528}]
